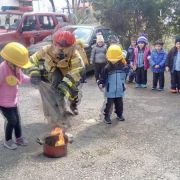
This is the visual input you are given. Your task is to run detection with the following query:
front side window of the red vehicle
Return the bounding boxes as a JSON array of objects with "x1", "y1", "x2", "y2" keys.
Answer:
[{"x1": 23, "y1": 16, "x2": 37, "y2": 31}]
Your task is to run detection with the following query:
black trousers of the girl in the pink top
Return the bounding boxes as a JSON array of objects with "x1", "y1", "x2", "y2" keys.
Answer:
[{"x1": 0, "y1": 106, "x2": 22, "y2": 141}]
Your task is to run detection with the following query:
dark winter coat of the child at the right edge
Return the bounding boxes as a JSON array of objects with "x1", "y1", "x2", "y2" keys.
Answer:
[{"x1": 165, "y1": 47, "x2": 177, "y2": 72}]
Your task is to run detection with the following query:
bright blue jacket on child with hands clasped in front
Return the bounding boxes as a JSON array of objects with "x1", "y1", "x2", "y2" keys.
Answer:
[{"x1": 150, "y1": 49, "x2": 167, "y2": 73}]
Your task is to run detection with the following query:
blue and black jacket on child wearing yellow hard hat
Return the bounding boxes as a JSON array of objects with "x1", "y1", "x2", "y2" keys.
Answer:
[{"x1": 98, "y1": 61, "x2": 126, "y2": 98}]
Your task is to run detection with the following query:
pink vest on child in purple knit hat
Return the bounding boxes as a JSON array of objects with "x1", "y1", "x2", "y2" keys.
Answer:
[{"x1": 134, "y1": 46, "x2": 151, "y2": 70}]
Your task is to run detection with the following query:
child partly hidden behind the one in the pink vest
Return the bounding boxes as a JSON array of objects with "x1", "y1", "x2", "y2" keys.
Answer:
[{"x1": 126, "y1": 35, "x2": 137, "y2": 83}]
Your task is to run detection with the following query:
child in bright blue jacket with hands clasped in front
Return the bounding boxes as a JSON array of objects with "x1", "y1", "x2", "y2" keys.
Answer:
[{"x1": 150, "y1": 40, "x2": 167, "y2": 91}]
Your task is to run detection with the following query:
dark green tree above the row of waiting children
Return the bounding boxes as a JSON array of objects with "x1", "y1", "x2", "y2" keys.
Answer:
[{"x1": 93, "y1": 0, "x2": 179, "y2": 45}]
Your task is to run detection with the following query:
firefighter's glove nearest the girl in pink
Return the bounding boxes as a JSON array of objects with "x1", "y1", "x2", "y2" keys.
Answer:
[{"x1": 29, "y1": 67, "x2": 41, "y2": 85}]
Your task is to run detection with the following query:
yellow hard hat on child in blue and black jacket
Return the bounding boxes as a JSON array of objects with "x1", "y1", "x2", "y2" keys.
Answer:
[{"x1": 106, "y1": 44, "x2": 124, "y2": 63}]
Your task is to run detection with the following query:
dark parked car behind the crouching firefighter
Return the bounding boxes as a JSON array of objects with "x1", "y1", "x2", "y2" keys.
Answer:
[{"x1": 28, "y1": 25, "x2": 119, "y2": 70}]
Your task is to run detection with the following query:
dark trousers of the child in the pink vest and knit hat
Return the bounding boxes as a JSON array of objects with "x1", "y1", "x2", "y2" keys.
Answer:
[{"x1": 136, "y1": 67, "x2": 147, "y2": 84}]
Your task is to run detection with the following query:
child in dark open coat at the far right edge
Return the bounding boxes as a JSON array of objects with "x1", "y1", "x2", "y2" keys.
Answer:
[{"x1": 166, "y1": 36, "x2": 180, "y2": 93}]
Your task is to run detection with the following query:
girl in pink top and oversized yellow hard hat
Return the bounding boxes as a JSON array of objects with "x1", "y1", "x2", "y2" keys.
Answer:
[{"x1": 0, "y1": 42, "x2": 30, "y2": 150}]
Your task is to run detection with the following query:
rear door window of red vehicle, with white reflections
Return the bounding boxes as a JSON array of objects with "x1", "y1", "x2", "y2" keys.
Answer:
[{"x1": 39, "y1": 15, "x2": 55, "y2": 29}]
